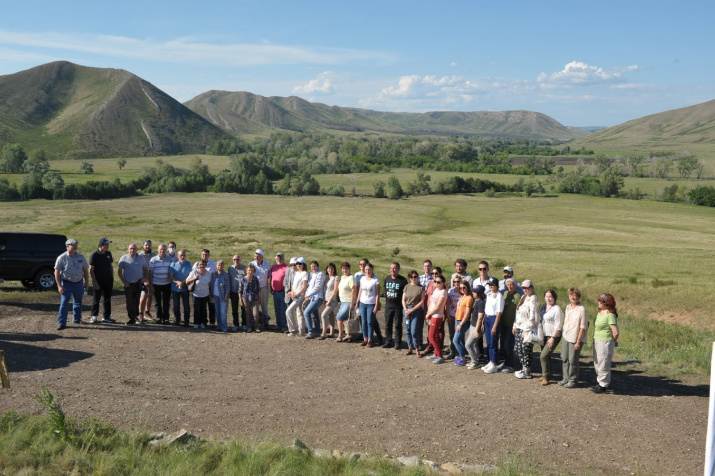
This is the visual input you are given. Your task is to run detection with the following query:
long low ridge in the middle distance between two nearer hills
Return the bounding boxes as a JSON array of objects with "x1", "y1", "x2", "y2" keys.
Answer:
[{"x1": 184, "y1": 91, "x2": 583, "y2": 140}]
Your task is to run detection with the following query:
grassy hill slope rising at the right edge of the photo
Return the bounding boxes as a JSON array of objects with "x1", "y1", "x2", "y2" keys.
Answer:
[{"x1": 572, "y1": 100, "x2": 715, "y2": 149}]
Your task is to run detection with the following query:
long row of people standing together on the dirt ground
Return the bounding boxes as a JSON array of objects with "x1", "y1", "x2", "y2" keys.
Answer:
[{"x1": 55, "y1": 238, "x2": 619, "y2": 393}]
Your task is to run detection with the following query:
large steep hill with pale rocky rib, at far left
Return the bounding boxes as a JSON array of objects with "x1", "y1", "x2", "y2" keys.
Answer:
[{"x1": 0, "y1": 61, "x2": 229, "y2": 157}]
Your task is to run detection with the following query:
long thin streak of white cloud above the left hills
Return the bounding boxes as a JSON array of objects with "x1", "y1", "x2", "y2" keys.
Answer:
[{"x1": 0, "y1": 30, "x2": 389, "y2": 66}]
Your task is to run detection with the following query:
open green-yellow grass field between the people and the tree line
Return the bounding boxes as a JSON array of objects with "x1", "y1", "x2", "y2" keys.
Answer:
[{"x1": 0, "y1": 189, "x2": 715, "y2": 371}]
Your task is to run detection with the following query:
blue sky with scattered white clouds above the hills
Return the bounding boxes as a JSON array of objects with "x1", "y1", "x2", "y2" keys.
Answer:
[{"x1": 0, "y1": 0, "x2": 715, "y2": 127}]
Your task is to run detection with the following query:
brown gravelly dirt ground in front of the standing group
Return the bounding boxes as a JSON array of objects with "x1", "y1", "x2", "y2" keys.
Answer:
[{"x1": 0, "y1": 296, "x2": 709, "y2": 474}]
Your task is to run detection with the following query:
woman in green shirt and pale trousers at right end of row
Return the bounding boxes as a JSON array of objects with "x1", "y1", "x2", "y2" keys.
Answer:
[{"x1": 589, "y1": 294, "x2": 619, "y2": 393}]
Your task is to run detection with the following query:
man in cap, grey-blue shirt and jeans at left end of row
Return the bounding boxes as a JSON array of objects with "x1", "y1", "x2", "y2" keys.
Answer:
[{"x1": 55, "y1": 238, "x2": 89, "y2": 331}]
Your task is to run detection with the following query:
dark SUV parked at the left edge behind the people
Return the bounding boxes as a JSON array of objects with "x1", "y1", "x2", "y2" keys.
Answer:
[{"x1": 0, "y1": 231, "x2": 67, "y2": 290}]
